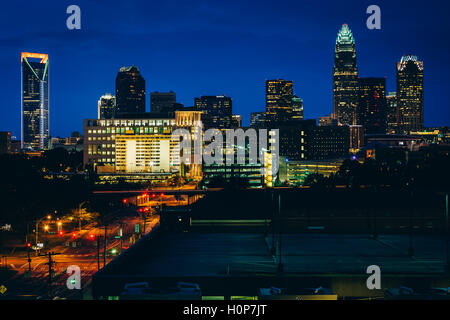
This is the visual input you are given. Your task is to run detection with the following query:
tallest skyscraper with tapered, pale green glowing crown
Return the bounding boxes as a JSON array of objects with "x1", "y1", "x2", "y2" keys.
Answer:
[{"x1": 333, "y1": 24, "x2": 358, "y2": 125}]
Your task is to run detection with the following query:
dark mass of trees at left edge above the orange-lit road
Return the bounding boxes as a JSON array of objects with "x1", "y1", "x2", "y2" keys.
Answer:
[{"x1": 0, "y1": 149, "x2": 91, "y2": 229}]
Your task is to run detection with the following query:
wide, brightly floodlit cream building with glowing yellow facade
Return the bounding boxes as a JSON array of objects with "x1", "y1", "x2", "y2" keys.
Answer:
[{"x1": 83, "y1": 111, "x2": 201, "y2": 177}]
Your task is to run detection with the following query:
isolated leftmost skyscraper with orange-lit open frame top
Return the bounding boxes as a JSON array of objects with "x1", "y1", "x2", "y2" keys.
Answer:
[{"x1": 21, "y1": 52, "x2": 50, "y2": 150}]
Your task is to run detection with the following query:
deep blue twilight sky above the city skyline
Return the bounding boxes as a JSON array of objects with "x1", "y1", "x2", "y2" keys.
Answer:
[{"x1": 0, "y1": 0, "x2": 450, "y2": 138}]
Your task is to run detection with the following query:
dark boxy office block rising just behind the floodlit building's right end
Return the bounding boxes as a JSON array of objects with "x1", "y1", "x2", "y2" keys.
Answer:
[{"x1": 194, "y1": 95, "x2": 233, "y2": 129}]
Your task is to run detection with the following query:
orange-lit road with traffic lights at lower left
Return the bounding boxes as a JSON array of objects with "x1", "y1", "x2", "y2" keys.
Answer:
[{"x1": 0, "y1": 215, "x2": 159, "y2": 299}]
